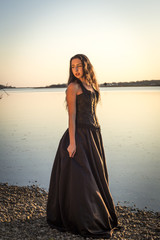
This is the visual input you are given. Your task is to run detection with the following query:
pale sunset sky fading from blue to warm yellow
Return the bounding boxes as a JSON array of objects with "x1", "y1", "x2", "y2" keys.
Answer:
[{"x1": 0, "y1": 0, "x2": 160, "y2": 87}]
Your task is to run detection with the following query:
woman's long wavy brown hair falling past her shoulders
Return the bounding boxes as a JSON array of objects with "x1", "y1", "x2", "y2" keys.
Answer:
[{"x1": 67, "y1": 54, "x2": 99, "y2": 92}]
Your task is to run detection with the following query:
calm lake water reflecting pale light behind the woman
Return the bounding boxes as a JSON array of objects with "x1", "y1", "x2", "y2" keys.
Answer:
[{"x1": 0, "y1": 87, "x2": 160, "y2": 211}]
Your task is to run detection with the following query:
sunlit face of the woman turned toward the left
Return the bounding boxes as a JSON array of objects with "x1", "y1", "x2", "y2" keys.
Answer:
[{"x1": 71, "y1": 58, "x2": 83, "y2": 79}]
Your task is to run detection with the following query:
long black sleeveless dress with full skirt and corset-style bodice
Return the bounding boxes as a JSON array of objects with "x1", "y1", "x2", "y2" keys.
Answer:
[{"x1": 47, "y1": 80, "x2": 118, "y2": 238}]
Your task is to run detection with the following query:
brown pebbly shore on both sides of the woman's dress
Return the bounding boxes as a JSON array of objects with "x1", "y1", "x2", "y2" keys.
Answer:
[{"x1": 0, "y1": 184, "x2": 160, "y2": 240}]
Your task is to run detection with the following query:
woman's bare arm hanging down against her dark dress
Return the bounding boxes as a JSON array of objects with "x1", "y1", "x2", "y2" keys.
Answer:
[{"x1": 67, "y1": 83, "x2": 78, "y2": 157}]
